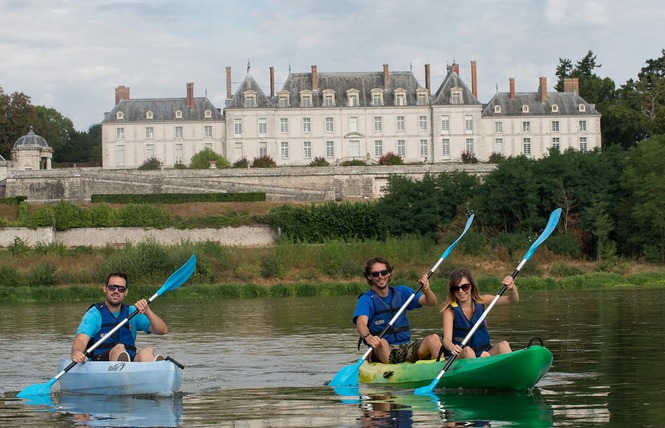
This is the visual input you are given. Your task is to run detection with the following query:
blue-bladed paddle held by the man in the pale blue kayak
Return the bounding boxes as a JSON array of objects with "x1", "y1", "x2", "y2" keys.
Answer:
[{"x1": 16, "y1": 255, "x2": 196, "y2": 398}]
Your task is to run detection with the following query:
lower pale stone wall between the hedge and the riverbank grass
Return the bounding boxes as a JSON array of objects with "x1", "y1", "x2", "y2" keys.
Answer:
[{"x1": 0, "y1": 226, "x2": 277, "y2": 248}]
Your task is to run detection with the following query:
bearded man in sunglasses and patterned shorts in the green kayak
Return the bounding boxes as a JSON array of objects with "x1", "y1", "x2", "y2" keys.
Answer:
[{"x1": 353, "y1": 257, "x2": 442, "y2": 364}]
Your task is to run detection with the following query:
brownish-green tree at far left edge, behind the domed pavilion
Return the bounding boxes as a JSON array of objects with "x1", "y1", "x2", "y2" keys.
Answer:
[{"x1": 0, "y1": 87, "x2": 37, "y2": 159}]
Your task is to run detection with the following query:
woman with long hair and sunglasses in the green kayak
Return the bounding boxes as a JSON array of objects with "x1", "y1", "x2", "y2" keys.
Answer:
[{"x1": 442, "y1": 269, "x2": 520, "y2": 358}]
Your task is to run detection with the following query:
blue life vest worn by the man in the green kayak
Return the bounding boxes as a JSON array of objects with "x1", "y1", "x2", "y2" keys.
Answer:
[{"x1": 364, "y1": 287, "x2": 411, "y2": 345}]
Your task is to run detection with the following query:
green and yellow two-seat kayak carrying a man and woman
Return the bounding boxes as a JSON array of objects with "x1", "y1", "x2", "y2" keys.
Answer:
[{"x1": 358, "y1": 345, "x2": 553, "y2": 390}]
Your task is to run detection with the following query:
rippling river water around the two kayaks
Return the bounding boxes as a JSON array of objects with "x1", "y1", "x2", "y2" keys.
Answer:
[{"x1": 0, "y1": 289, "x2": 665, "y2": 427}]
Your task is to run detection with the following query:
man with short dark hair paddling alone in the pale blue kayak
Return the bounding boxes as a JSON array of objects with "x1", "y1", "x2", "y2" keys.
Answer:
[{"x1": 71, "y1": 272, "x2": 168, "y2": 363}]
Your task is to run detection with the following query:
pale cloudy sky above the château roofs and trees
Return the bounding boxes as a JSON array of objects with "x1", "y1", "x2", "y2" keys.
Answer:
[{"x1": 0, "y1": 0, "x2": 665, "y2": 131}]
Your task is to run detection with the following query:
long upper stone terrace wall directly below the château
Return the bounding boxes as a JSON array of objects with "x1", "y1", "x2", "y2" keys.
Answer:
[{"x1": 4, "y1": 163, "x2": 496, "y2": 203}]
